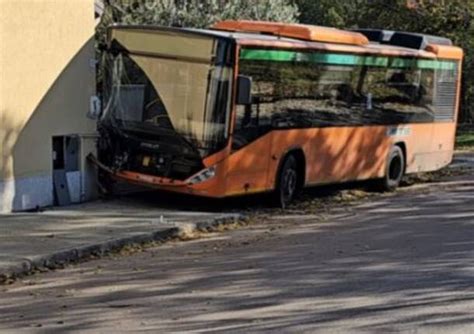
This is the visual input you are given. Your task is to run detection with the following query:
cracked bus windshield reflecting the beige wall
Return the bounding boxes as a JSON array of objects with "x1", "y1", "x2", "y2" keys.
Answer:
[{"x1": 103, "y1": 53, "x2": 232, "y2": 157}]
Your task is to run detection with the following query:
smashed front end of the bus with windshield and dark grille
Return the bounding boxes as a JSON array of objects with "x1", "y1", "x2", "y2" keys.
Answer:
[{"x1": 99, "y1": 26, "x2": 235, "y2": 196}]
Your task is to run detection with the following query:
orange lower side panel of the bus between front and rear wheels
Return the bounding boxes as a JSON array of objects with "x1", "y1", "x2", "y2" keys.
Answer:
[{"x1": 269, "y1": 127, "x2": 391, "y2": 184}]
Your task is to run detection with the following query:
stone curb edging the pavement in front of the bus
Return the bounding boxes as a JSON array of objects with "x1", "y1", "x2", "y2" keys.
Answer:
[{"x1": 0, "y1": 214, "x2": 246, "y2": 285}]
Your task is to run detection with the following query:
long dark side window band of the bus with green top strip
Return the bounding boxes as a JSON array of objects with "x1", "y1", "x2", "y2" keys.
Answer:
[{"x1": 234, "y1": 49, "x2": 458, "y2": 147}]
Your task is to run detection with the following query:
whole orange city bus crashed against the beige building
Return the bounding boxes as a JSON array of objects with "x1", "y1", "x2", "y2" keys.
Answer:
[{"x1": 98, "y1": 21, "x2": 463, "y2": 207}]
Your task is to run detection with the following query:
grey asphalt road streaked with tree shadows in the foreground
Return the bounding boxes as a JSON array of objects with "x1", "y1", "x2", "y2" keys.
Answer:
[{"x1": 0, "y1": 176, "x2": 474, "y2": 333}]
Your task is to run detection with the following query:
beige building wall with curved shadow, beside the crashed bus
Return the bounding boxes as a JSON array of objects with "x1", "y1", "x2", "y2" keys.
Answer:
[{"x1": 0, "y1": 0, "x2": 95, "y2": 212}]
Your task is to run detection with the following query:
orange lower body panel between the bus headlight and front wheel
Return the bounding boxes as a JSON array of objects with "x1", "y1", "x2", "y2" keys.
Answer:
[{"x1": 226, "y1": 134, "x2": 272, "y2": 196}]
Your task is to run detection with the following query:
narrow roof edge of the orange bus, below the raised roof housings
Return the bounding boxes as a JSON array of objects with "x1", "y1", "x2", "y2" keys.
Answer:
[{"x1": 110, "y1": 25, "x2": 463, "y2": 59}]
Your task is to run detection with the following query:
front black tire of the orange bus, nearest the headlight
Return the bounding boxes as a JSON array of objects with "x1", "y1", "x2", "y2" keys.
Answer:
[{"x1": 273, "y1": 155, "x2": 300, "y2": 209}]
